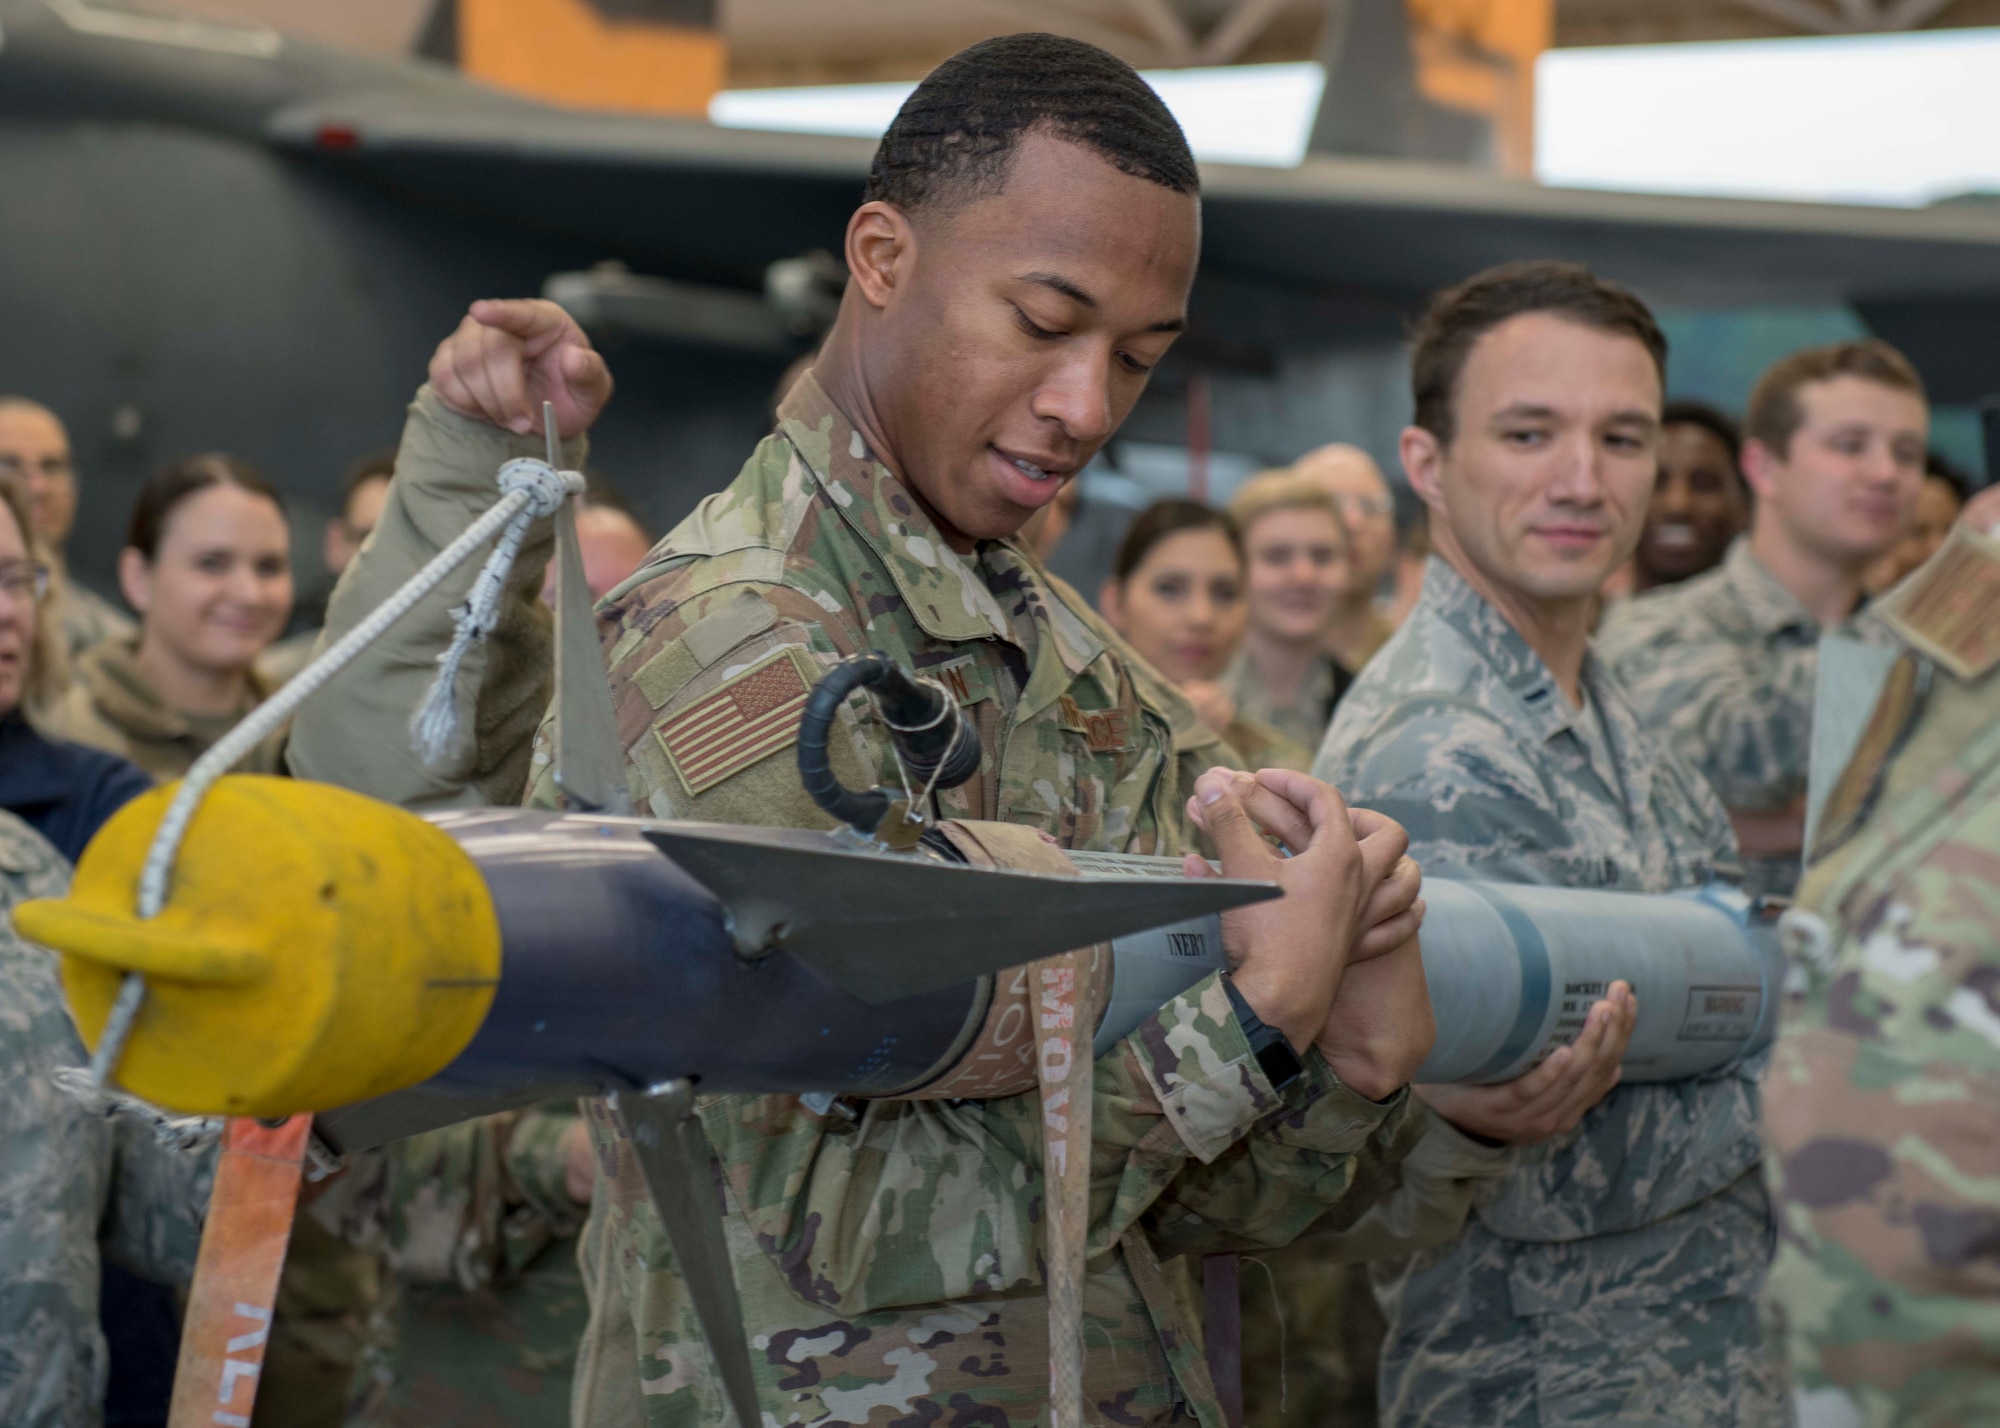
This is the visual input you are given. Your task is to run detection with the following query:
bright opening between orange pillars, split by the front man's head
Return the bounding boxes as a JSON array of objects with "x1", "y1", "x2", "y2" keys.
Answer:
[{"x1": 708, "y1": 64, "x2": 1326, "y2": 168}]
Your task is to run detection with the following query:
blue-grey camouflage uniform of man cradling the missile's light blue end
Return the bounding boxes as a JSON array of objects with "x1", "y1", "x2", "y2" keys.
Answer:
[{"x1": 1314, "y1": 558, "x2": 1782, "y2": 1428}]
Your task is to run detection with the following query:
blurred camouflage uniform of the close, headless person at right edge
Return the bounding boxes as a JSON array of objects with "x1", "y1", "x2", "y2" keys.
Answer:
[{"x1": 1764, "y1": 526, "x2": 2000, "y2": 1428}]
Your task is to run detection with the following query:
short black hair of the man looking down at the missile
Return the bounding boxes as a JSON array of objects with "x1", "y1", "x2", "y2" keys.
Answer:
[{"x1": 866, "y1": 34, "x2": 1200, "y2": 216}]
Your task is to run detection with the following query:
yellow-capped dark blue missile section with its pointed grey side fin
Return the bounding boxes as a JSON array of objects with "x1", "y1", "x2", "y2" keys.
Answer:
[{"x1": 16, "y1": 776, "x2": 1276, "y2": 1128}]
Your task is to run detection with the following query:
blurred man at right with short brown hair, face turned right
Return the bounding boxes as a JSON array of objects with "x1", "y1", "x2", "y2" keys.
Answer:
[{"x1": 1598, "y1": 340, "x2": 1928, "y2": 896}]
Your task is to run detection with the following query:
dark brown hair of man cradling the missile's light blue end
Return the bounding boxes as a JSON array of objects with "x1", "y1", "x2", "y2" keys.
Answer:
[{"x1": 1410, "y1": 262, "x2": 1666, "y2": 446}]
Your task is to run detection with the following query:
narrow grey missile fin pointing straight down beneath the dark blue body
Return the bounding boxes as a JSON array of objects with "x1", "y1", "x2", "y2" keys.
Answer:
[{"x1": 606, "y1": 1078, "x2": 764, "y2": 1428}]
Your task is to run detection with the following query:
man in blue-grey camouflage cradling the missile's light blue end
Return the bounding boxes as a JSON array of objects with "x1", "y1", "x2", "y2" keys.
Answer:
[{"x1": 1316, "y1": 264, "x2": 1782, "y2": 1428}]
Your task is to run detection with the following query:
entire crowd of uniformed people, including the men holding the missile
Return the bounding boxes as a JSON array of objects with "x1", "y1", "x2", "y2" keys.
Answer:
[{"x1": 0, "y1": 19, "x2": 2000, "y2": 1428}]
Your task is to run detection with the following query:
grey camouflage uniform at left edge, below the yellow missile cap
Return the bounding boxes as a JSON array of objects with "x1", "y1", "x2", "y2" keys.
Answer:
[{"x1": 0, "y1": 814, "x2": 214, "y2": 1428}]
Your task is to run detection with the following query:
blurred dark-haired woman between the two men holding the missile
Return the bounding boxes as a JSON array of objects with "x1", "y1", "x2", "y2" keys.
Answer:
[{"x1": 1098, "y1": 500, "x2": 1312, "y2": 770}]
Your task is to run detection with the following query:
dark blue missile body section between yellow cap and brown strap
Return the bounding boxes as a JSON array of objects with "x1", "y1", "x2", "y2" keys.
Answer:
[{"x1": 430, "y1": 808, "x2": 990, "y2": 1096}]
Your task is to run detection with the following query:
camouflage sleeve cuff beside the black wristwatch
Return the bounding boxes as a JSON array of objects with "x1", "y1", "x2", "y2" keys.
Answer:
[{"x1": 1126, "y1": 972, "x2": 1332, "y2": 1164}]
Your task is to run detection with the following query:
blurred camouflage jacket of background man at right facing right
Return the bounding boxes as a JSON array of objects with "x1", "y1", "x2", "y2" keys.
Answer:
[{"x1": 1598, "y1": 536, "x2": 1870, "y2": 898}]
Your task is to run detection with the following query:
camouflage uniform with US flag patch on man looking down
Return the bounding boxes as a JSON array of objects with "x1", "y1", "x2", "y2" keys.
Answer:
[{"x1": 536, "y1": 376, "x2": 1408, "y2": 1426}]
